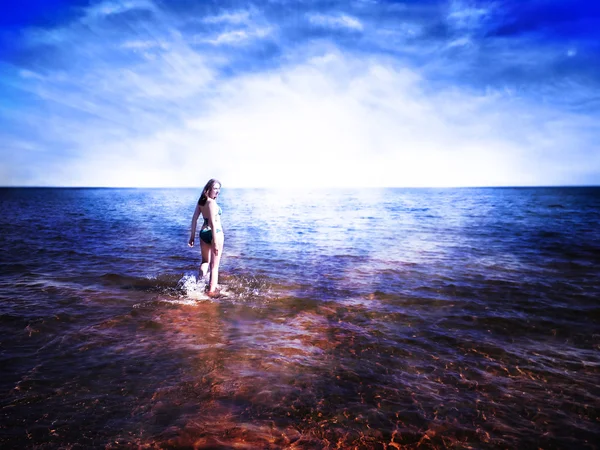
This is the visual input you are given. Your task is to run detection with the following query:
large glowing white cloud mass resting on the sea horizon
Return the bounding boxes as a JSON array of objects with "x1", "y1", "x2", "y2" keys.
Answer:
[{"x1": 59, "y1": 49, "x2": 596, "y2": 187}]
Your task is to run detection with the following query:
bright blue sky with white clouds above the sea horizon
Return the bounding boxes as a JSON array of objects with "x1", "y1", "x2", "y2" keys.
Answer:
[{"x1": 0, "y1": 0, "x2": 600, "y2": 188}]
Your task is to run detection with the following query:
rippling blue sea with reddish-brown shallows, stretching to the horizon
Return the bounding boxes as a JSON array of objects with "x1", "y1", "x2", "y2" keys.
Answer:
[{"x1": 0, "y1": 185, "x2": 600, "y2": 449}]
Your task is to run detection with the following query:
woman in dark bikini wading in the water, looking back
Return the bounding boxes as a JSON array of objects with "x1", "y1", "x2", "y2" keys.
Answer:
[{"x1": 188, "y1": 178, "x2": 225, "y2": 297}]
